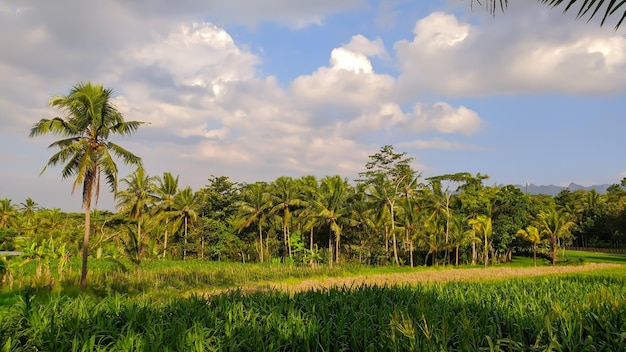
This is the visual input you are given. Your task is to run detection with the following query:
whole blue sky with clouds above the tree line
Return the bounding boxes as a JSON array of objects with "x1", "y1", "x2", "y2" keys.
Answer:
[{"x1": 0, "y1": 0, "x2": 626, "y2": 211}]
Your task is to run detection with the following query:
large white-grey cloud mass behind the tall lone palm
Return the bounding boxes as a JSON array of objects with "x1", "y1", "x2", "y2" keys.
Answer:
[{"x1": 0, "y1": 0, "x2": 494, "y2": 210}]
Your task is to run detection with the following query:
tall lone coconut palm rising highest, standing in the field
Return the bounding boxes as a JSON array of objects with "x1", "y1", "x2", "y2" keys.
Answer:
[{"x1": 29, "y1": 83, "x2": 142, "y2": 289}]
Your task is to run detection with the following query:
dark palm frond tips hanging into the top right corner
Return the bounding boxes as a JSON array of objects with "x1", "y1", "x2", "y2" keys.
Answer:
[{"x1": 472, "y1": 0, "x2": 626, "y2": 30}]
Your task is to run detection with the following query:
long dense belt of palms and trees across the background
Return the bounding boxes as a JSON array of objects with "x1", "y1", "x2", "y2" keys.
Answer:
[{"x1": 0, "y1": 146, "x2": 626, "y2": 280}]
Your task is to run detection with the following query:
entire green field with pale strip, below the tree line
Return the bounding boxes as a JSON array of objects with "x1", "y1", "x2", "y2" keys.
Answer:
[{"x1": 0, "y1": 253, "x2": 626, "y2": 351}]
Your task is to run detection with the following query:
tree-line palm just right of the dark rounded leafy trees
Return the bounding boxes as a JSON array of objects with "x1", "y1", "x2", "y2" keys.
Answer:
[{"x1": 237, "y1": 182, "x2": 272, "y2": 263}]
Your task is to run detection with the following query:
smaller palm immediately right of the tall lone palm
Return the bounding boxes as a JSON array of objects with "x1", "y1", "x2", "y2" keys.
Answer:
[{"x1": 115, "y1": 166, "x2": 157, "y2": 258}]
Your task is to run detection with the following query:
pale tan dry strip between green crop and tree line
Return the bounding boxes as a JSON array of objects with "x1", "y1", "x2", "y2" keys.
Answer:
[{"x1": 264, "y1": 264, "x2": 623, "y2": 293}]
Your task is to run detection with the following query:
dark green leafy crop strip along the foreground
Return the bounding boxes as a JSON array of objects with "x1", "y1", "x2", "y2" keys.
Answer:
[{"x1": 0, "y1": 273, "x2": 626, "y2": 351}]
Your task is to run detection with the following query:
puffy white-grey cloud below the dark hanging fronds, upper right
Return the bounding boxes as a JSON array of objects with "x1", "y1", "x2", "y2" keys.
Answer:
[{"x1": 394, "y1": 9, "x2": 626, "y2": 98}]
